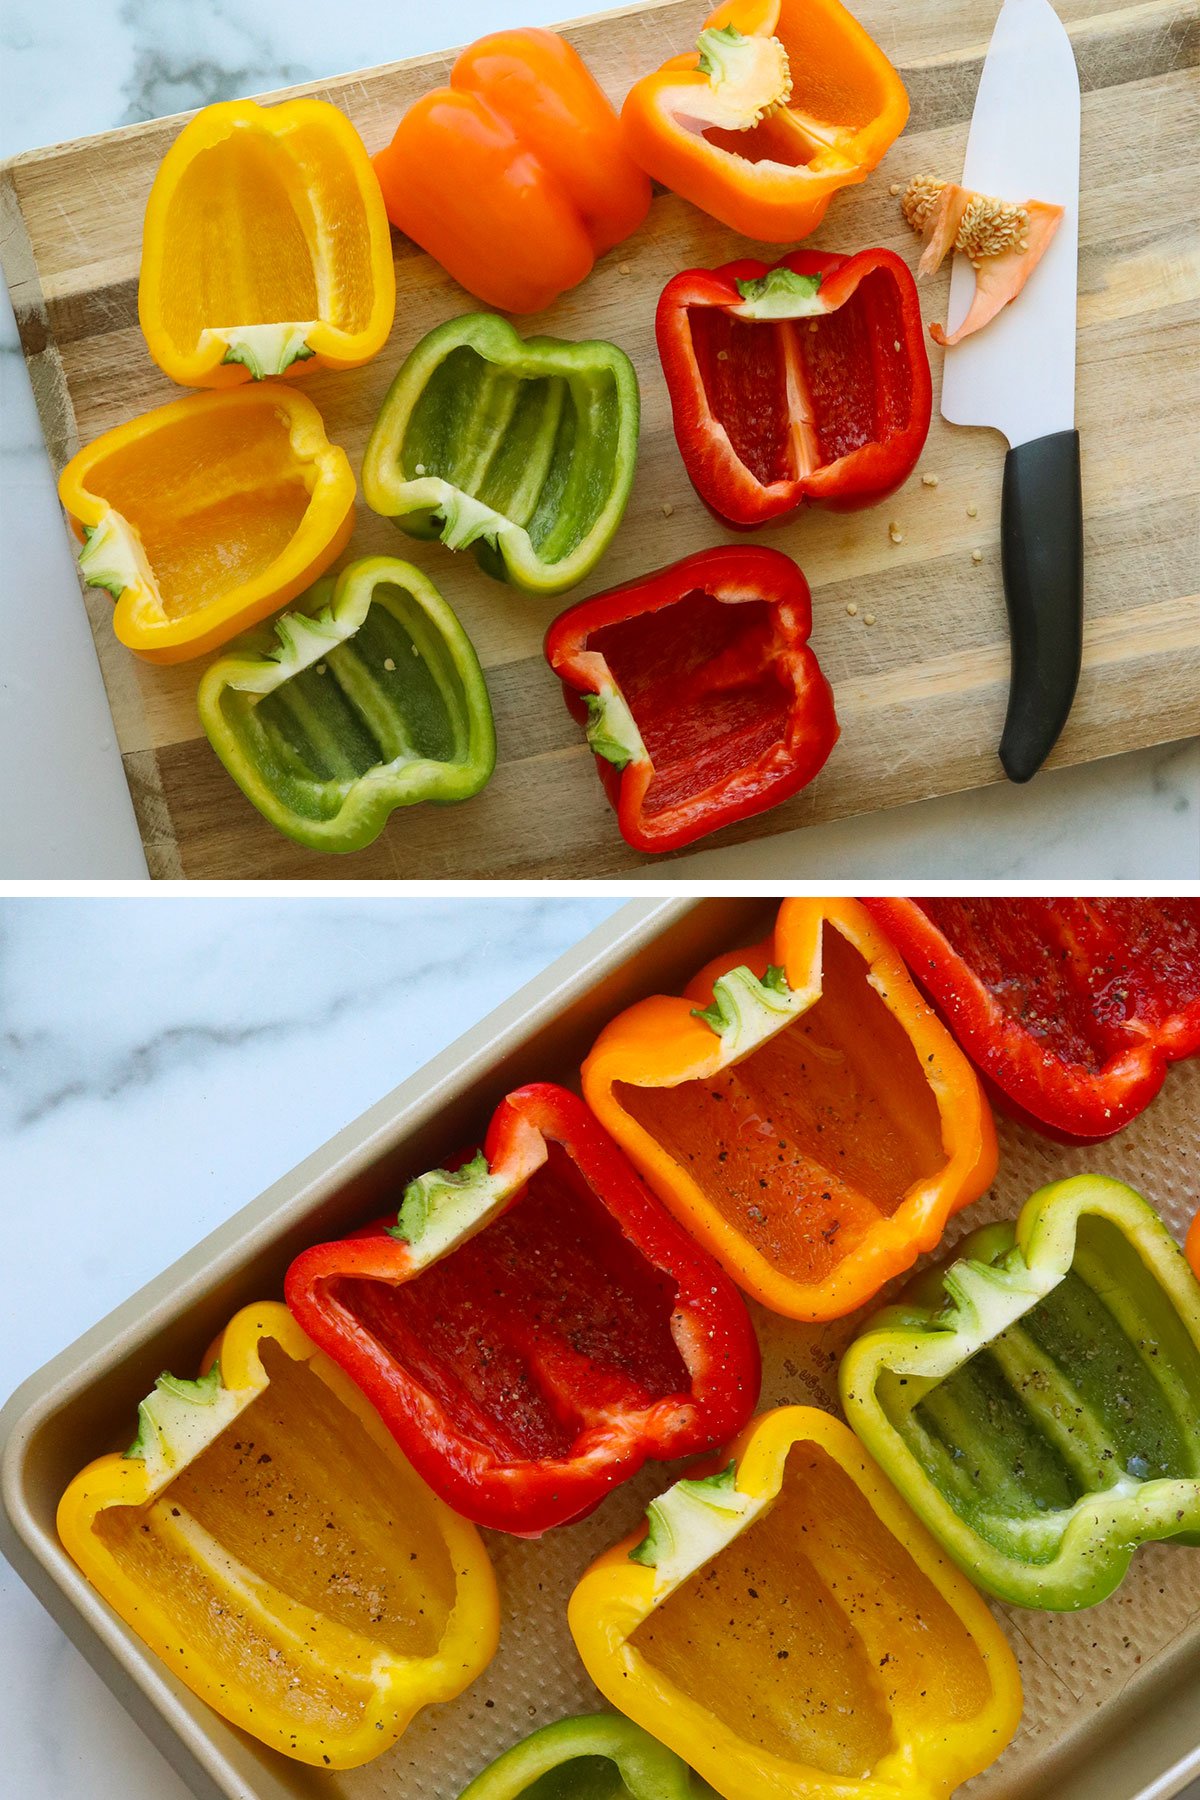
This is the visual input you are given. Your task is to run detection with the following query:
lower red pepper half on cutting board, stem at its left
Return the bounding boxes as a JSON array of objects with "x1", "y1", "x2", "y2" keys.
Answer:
[{"x1": 545, "y1": 545, "x2": 838, "y2": 851}]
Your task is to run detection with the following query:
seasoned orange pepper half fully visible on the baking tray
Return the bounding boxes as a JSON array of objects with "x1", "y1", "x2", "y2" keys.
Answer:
[{"x1": 583, "y1": 898, "x2": 997, "y2": 1319}]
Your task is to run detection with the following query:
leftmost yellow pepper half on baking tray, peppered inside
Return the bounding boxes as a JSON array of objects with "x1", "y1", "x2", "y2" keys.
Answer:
[{"x1": 58, "y1": 1301, "x2": 500, "y2": 1769}]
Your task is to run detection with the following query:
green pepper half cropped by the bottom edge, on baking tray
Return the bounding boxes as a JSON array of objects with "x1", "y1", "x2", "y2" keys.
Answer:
[{"x1": 459, "y1": 1712, "x2": 716, "y2": 1800}]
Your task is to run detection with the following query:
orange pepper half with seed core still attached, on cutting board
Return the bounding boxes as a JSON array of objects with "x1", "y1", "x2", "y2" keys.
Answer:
[{"x1": 621, "y1": 0, "x2": 909, "y2": 243}]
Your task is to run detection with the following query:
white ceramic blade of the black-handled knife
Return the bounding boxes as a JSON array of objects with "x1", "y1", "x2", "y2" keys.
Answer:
[{"x1": 941, "y1": 0, "x2": 1079, "y2": 446}]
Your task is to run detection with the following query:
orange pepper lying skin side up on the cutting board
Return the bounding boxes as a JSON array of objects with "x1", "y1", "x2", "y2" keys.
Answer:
[{"x1": 374, "y1": 31, "x2": 649, "y2": 313}]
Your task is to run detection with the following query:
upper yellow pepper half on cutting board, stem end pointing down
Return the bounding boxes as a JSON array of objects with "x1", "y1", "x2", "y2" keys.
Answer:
[{"x1": 137, "y1": 99, "x2": 396, "y2": 387}]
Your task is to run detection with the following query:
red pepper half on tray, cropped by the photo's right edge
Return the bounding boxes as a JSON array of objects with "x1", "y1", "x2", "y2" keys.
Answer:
[{"x1": 864, "y1": 898, "x2": 1200, "y2": 1143}]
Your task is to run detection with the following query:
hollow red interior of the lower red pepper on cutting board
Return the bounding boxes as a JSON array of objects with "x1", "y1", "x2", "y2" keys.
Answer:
[{"x1": 588, "y1": 589, "x2": 793, "y2": 817}]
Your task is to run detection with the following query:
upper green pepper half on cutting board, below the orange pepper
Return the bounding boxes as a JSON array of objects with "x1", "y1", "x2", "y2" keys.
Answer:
[{"x1": 362, "y1": 313, "x2": 639, "y2": 594}]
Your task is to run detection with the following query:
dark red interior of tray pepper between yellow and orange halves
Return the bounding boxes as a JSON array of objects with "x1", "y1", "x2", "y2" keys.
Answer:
[{"x1": 329, "y1": 1143, "x2": 691, "y2": 1462}]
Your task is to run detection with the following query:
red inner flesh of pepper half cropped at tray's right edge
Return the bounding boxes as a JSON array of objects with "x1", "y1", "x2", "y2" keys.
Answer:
[{"x1": 918, "y1": 898, "x2": 1200, "y2": 1075}]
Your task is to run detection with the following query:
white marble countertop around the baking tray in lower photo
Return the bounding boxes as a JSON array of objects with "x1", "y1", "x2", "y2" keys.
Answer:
[{"x1": 0, "y1": 896, "x2": 613, "y2": 1800}]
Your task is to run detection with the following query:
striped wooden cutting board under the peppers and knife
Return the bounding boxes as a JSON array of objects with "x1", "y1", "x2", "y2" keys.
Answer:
[{"x1": 0, "y1": 0, "x2": 1200, "y2": 878}]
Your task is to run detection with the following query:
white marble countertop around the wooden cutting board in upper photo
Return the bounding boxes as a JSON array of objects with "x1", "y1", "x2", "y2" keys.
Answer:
[{"x1": 0, "y1": 0, "x2": 1200, "y2": 880}]
